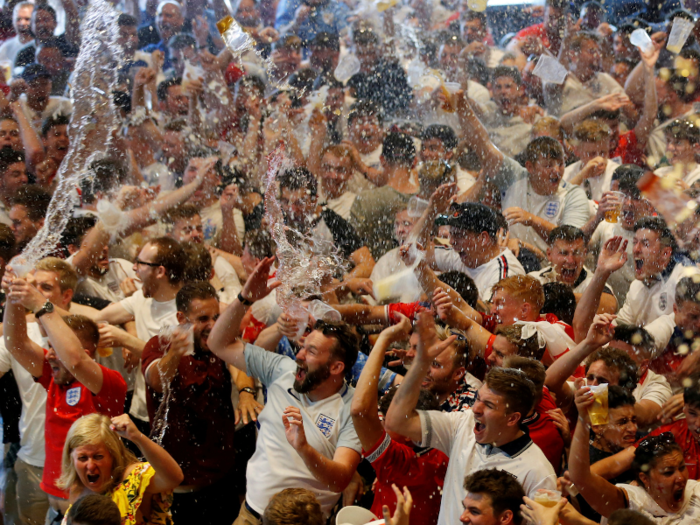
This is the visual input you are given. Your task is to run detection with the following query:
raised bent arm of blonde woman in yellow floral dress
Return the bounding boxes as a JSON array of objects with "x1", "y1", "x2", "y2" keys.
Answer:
[{"x1": 111, "y1": 414, "x2": 185, "y2": 494}]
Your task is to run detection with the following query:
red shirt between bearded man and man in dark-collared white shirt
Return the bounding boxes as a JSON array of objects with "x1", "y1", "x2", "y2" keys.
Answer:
[{"x1": 362, "y1": 434, "x2": 448, "y2": 525}]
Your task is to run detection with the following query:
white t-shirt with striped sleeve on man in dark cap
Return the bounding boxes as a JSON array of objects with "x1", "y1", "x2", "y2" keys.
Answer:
[{"x1": 435, "y1": 248, "x2": 525, "y2": 301}]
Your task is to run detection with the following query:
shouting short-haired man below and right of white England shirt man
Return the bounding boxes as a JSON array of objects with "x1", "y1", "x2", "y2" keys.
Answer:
[{"x1": 529, "y1": 225, "x2": 617, "y2": 314}]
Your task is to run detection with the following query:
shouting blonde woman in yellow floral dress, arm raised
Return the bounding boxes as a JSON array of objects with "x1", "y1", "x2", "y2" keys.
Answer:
[{"x1": 58, "y1": 414, "x2": 183, "y2": 525}]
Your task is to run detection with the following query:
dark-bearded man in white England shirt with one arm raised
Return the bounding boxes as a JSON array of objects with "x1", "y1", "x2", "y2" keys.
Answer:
[{"x1": 209, "y1": 258, "x2": 361, "y2": 525}]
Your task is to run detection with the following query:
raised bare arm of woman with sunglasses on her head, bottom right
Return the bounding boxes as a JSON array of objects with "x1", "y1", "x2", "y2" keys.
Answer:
[{"x1": 569, "y1": 379, "x2": 627, "y2": 518}]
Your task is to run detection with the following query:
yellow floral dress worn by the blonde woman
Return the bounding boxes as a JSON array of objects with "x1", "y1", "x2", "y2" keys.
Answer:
[{"x1": 62, "y1": 463, "x2": 173, "y2": 525}]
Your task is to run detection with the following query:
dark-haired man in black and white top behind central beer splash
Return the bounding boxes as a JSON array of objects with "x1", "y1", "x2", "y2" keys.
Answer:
[{"x1": 279, "y1": 168, "x2": 374, "y2": 280}]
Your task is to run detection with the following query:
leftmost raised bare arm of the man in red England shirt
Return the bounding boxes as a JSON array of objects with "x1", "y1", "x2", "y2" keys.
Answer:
[{"x1": 2, "y1": 271, "x2": 44, "y2": 377}]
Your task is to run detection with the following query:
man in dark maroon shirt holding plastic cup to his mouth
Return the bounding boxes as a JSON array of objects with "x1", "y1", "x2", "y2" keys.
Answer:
[{"x1": 141, "y1": 282, "x2": 242, "y2": 525}]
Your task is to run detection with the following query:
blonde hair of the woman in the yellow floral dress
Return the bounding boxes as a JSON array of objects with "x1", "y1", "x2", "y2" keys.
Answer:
[{"x1": 56, "y1": 414, "x2": 138, "y2": 492}]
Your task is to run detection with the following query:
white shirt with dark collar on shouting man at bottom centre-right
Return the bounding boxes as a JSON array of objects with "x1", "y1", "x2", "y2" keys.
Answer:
[{"x1": 418, "y1": 410, "x2": 557, "y2": 525}]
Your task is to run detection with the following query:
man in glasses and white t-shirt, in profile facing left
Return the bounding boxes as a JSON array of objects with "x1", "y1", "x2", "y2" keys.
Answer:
[{"x1": 94, "y1": 237, "x2": 185, "y2": 432}]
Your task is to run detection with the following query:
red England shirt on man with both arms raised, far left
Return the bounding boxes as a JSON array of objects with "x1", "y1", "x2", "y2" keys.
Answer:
[{"x1": 34, "y1": 354, "x2": 126, "y2": 499}]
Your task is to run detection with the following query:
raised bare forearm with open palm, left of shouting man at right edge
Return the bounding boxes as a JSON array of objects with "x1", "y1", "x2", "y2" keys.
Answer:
[{"x1": 573, "y1": 237, "x2": 627, "y2": 342}]
